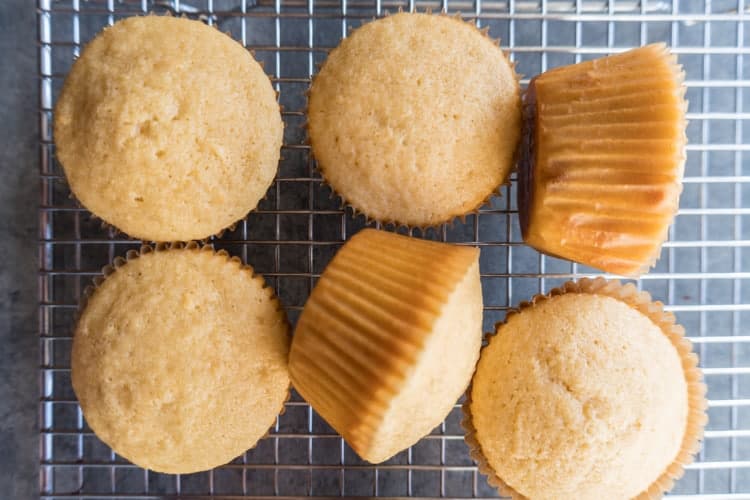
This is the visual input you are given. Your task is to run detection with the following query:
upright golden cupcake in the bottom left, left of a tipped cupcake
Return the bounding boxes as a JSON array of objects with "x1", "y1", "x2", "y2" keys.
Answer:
[{"x1": 71, "y1": 244, "x2": 289, "y2": 474}]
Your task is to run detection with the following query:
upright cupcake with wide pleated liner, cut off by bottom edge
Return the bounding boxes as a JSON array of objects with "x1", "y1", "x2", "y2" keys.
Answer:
[{"x1": 464, "y1": 278, "x2": 706, "y2": 499}]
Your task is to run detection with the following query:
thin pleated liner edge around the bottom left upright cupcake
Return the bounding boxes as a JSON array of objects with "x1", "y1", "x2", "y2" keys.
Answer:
[{"x1": 73, "y1": 241, "x2": 291, "y2": 472}]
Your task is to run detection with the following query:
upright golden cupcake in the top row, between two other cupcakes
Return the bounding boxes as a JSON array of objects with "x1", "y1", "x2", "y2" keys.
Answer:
[{"x1": 308, "y1": 13, "x2": 521, "y2": 227}]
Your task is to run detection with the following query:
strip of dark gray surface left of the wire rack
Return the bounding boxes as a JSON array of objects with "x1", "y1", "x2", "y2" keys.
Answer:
[{"x1": 0, "y1": 0, "x2": 39, "y2": 499}]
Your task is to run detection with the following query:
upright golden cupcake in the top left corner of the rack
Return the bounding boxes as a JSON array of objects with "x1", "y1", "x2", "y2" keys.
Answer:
[{"x1": 54, "y1": 16, "x2": 283, "y2": 241}]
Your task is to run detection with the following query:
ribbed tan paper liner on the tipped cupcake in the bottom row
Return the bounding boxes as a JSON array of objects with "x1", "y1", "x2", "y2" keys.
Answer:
[{"x1": 289, "y1": 229, "x2": 478, "y2": 461}]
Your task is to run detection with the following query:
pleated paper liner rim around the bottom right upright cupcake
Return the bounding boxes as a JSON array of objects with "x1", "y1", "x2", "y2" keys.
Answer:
[{"x1": 461, "y1": 278, "x2": 708, "y2": 500}]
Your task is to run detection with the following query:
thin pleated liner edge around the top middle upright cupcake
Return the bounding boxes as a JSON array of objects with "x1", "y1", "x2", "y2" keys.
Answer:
[{"x1": 303, "y1": 7, "x2": 523, "y2": 234}]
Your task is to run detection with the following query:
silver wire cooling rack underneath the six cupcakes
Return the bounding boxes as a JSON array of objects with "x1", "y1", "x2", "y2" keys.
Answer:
[{"x1": 38, "y1": 0, "x2": 750, "y2": 499}]
